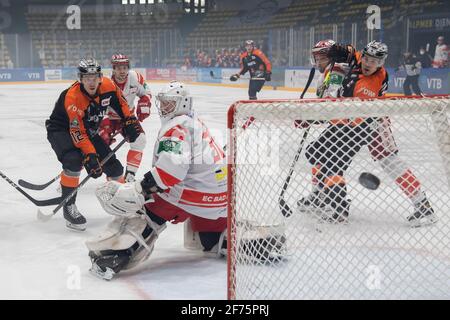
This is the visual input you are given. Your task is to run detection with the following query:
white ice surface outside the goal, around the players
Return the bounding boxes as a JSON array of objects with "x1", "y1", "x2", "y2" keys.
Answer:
[{"x1": 0, "y1": 83, "x2": 299, "y2": 299}]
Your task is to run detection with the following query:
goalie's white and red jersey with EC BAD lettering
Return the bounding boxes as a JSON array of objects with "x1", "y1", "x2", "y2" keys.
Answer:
[{"x1": 151, "y1": 114, "x2": 227, "y2": 220}]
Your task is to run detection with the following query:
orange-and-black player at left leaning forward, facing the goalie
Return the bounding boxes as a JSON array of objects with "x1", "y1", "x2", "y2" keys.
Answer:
[{"x1": 45, "y1": 59, "x2": 142, "y2": 231}]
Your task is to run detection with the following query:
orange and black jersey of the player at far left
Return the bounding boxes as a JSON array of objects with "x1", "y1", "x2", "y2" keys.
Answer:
[{"x1": 46, "y1": 77, "x2": 131, "y2": 154}]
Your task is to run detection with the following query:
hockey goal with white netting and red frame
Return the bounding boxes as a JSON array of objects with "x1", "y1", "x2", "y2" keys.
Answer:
[{"x1": 228, "y1": 96, "x2": 450, "y2": 299}]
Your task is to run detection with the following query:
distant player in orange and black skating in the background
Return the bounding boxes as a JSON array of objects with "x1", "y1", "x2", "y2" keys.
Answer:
[{"x1": 230, "y1": 40, "x2": 272, "y2": 100}]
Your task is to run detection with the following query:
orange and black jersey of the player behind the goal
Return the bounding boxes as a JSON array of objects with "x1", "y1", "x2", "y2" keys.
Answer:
[{"x1": 341, "y1": 52, "x2": 389, "y2": 98}]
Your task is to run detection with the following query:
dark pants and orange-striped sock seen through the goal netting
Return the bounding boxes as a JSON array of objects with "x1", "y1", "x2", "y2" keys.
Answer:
[{"x1": 305, "y1": 118, "x2": 377, "y2": 205}]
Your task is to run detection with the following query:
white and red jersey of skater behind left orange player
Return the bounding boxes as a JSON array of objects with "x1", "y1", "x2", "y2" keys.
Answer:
[{"x1": 108, "y1": 70, "x2": 152, "y2": 120}]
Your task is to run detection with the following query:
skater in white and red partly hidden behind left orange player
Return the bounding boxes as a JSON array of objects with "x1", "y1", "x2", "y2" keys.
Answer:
[{"x1": 100, "y1": 54, "x2": 152, "y2": 181}]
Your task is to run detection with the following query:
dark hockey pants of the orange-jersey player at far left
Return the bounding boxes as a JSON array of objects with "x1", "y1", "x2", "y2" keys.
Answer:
[{"x1": 47, "y1": 131, "x2": 123, "y2": 177}]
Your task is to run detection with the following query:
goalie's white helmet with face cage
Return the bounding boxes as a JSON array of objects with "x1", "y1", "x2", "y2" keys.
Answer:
[{"x1": 156, "y1": 80, "x2": 192, "y2": 119}]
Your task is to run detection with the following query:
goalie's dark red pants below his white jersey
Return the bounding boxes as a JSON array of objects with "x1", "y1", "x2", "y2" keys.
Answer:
[{"x1": 145, "y1": 194, "x2": 227, "y2": 232}]
